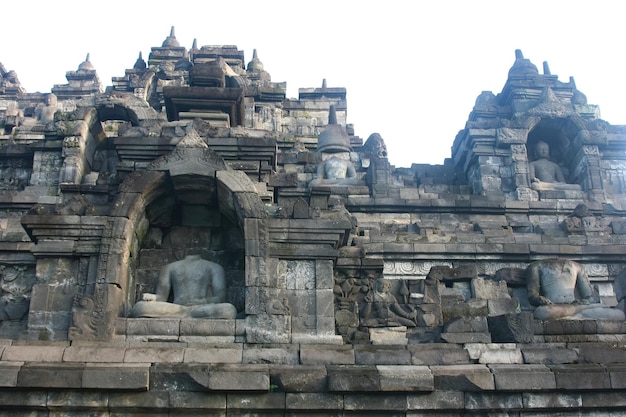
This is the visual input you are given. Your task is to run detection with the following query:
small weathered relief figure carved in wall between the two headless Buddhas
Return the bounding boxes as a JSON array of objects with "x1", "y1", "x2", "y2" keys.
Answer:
[{"x1": 361, "y1": 278, "x2": 418, "y2": 327}]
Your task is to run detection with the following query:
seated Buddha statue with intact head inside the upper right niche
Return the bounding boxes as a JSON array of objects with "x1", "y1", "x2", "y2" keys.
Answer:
[{"x1": 528, "y1": 141, "x2": 581, "y2": 190}]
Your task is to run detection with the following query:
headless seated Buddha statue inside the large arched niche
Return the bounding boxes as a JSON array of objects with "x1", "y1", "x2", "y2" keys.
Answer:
[{"x1": 131, "y1": 255, "x2": 237, "y2": 319}]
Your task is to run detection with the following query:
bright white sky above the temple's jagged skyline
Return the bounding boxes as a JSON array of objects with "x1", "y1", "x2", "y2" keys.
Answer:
[{"x1": 0, "y1": 0, "x2": 626, "y2": 167}]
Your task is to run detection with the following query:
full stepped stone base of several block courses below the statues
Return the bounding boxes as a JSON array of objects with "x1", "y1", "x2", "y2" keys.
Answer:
[{"x1": 0, "y1": 335, "x2": 626, "y2": 417}]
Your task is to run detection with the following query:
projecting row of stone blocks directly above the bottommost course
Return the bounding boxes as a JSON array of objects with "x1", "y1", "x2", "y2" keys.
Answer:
[{"x1": 0, "y1": 362, "x2": 626, "y2": 393}]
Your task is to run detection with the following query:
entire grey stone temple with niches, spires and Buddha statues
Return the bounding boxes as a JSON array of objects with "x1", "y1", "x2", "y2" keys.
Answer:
[{"x1": 0, "y1": 29, "x2": 626, "y2": 417}]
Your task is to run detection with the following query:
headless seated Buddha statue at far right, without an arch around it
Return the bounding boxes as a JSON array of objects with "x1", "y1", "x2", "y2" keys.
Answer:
[{"x1": 526, "y1": 258, "x2": 625, "y2": 321}]
